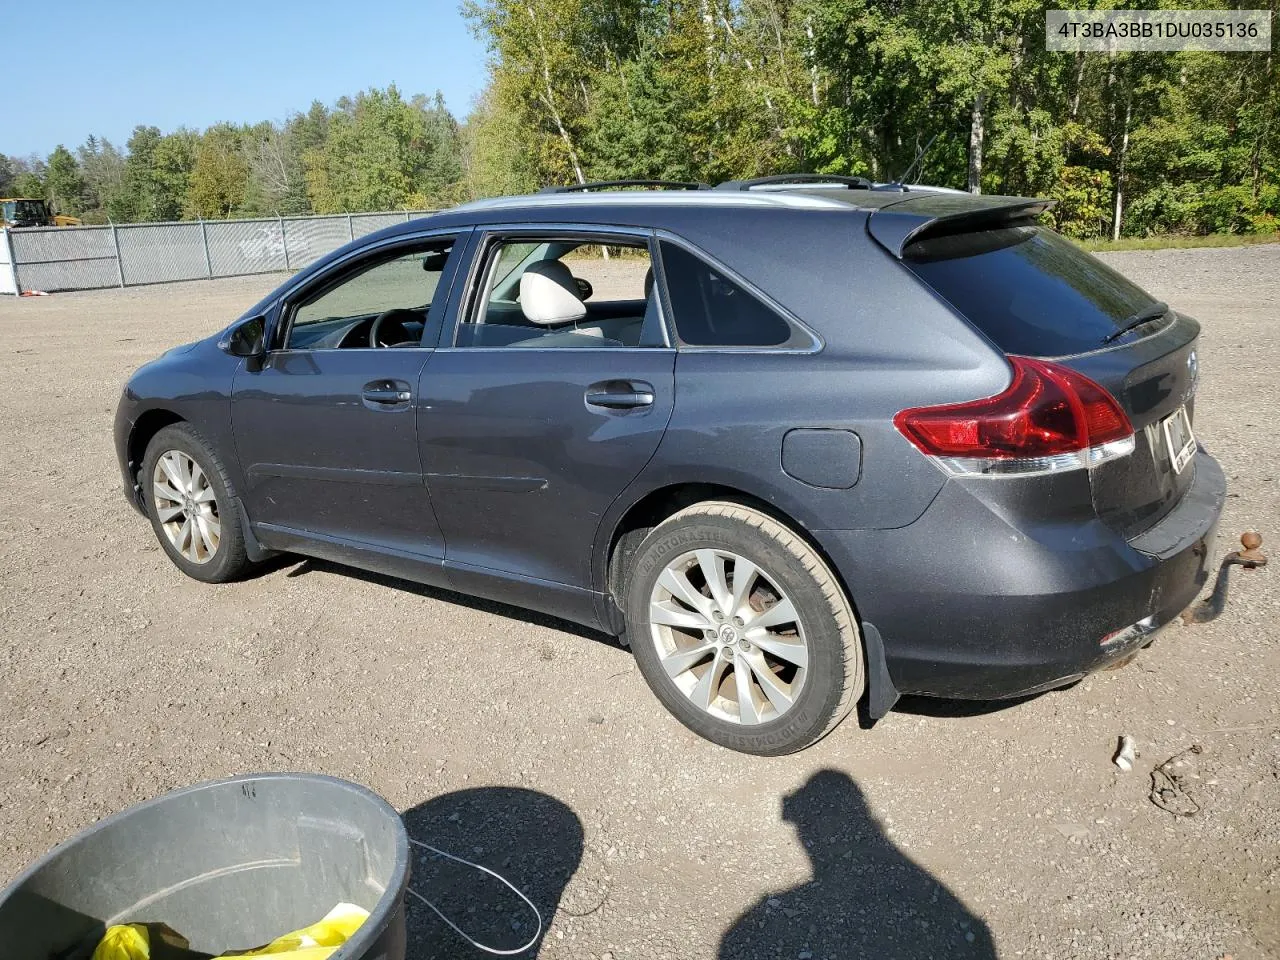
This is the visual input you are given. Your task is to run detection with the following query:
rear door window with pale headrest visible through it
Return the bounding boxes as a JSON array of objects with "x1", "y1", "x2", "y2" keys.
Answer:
[{"x1": 454, "y1": 236, "x2": 667, "y2": 349}]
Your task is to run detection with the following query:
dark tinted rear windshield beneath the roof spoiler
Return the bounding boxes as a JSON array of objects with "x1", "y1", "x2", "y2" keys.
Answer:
[{"x1": 902, "y1": 224, "x2": 1156, "y2": 357}]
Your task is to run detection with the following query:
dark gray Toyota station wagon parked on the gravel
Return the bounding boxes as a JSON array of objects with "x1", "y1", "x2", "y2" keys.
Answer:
[{"x1": 115, "y1": 177, "x2": 1225, "y2": 754}]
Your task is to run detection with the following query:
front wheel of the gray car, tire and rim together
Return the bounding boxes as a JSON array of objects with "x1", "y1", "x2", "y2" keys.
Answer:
[{"x1": 138, "y1": 424, "x2": 253, "y2": 584}]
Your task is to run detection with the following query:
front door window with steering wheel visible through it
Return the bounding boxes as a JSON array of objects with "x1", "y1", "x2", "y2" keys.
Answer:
[{"x1": 284, "y1": 237, "x2": 453, "y2": 349}]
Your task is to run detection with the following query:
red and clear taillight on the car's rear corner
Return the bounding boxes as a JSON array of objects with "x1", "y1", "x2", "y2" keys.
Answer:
[{"x1": 893, "y1": 357, "x2": 1134, "y2": 475}]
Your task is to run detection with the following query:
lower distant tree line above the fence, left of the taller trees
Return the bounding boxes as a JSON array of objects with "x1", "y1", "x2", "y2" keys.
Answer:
[{"x1": 0, "y1": 87, "x2": 466, "y2": 223}]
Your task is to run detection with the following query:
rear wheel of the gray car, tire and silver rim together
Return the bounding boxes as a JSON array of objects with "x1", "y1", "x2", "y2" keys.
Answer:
[{"x1": 625, "y1": 500, "x2": 865, "y2": 756}]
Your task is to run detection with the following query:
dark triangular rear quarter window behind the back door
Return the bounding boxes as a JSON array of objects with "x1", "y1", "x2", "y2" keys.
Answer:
[{"x1": 662, "y1": 241, "x2": 791, "y2": 347}]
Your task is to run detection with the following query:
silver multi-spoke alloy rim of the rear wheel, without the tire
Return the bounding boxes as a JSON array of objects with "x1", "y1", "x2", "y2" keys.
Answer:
[{"x1": 649, "y1": 549, "x2": 809, "y2": 724}]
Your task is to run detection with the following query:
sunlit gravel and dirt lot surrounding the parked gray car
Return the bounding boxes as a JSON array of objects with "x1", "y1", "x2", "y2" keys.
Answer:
[{"x1": 0, "y1": 246, "x2": 1280, "y2": 960}]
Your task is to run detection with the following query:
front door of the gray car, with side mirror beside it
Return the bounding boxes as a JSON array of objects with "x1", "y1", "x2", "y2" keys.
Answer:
[{"x1": 232, "y1": 234, "x2": 466, "y2": 559}]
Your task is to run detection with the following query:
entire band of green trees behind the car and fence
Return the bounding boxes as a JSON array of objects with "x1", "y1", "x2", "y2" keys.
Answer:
[{"x1": 0, "y1": 0, "x2": 1280, "y2": 239}]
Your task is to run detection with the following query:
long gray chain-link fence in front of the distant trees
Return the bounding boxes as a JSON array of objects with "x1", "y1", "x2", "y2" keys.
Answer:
[{"x1": 0, "y1": 210, "x2": 433, "y2": 293}]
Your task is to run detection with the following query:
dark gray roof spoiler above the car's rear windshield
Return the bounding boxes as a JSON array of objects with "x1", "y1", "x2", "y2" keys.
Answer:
[{"x1": 867, "y1": 193, "x2": 1055, "y2": 260}]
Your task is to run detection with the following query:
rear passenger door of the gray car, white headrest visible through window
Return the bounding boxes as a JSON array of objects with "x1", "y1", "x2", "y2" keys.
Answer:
[{"x1": 419, "y1": 229, "x2": 676, "y2": 616}]
